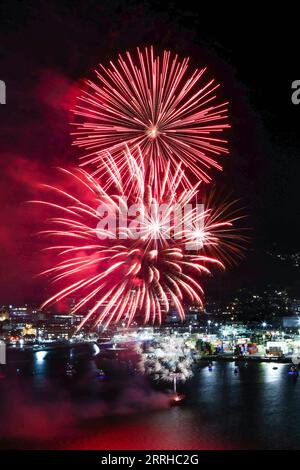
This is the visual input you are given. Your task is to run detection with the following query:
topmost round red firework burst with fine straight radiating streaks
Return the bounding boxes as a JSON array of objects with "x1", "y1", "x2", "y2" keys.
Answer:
[{"x1": 72, "y1": 47, "x2": 230, "y2": 185}]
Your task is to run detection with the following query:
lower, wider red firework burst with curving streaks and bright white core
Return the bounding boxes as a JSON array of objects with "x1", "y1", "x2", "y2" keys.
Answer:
[{"x1": 36, "y1": 151, "x2": 243, "y2": 327}]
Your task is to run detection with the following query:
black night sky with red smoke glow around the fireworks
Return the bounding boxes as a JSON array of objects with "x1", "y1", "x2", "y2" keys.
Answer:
[{"x1": 0, "y1": 0, "x2": 300, "y2": 304}]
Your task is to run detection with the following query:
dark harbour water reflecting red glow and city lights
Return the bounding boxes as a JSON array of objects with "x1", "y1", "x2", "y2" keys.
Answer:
[{"x1": 0, "y1": 348, "x2": 300, "y2": 450}]
